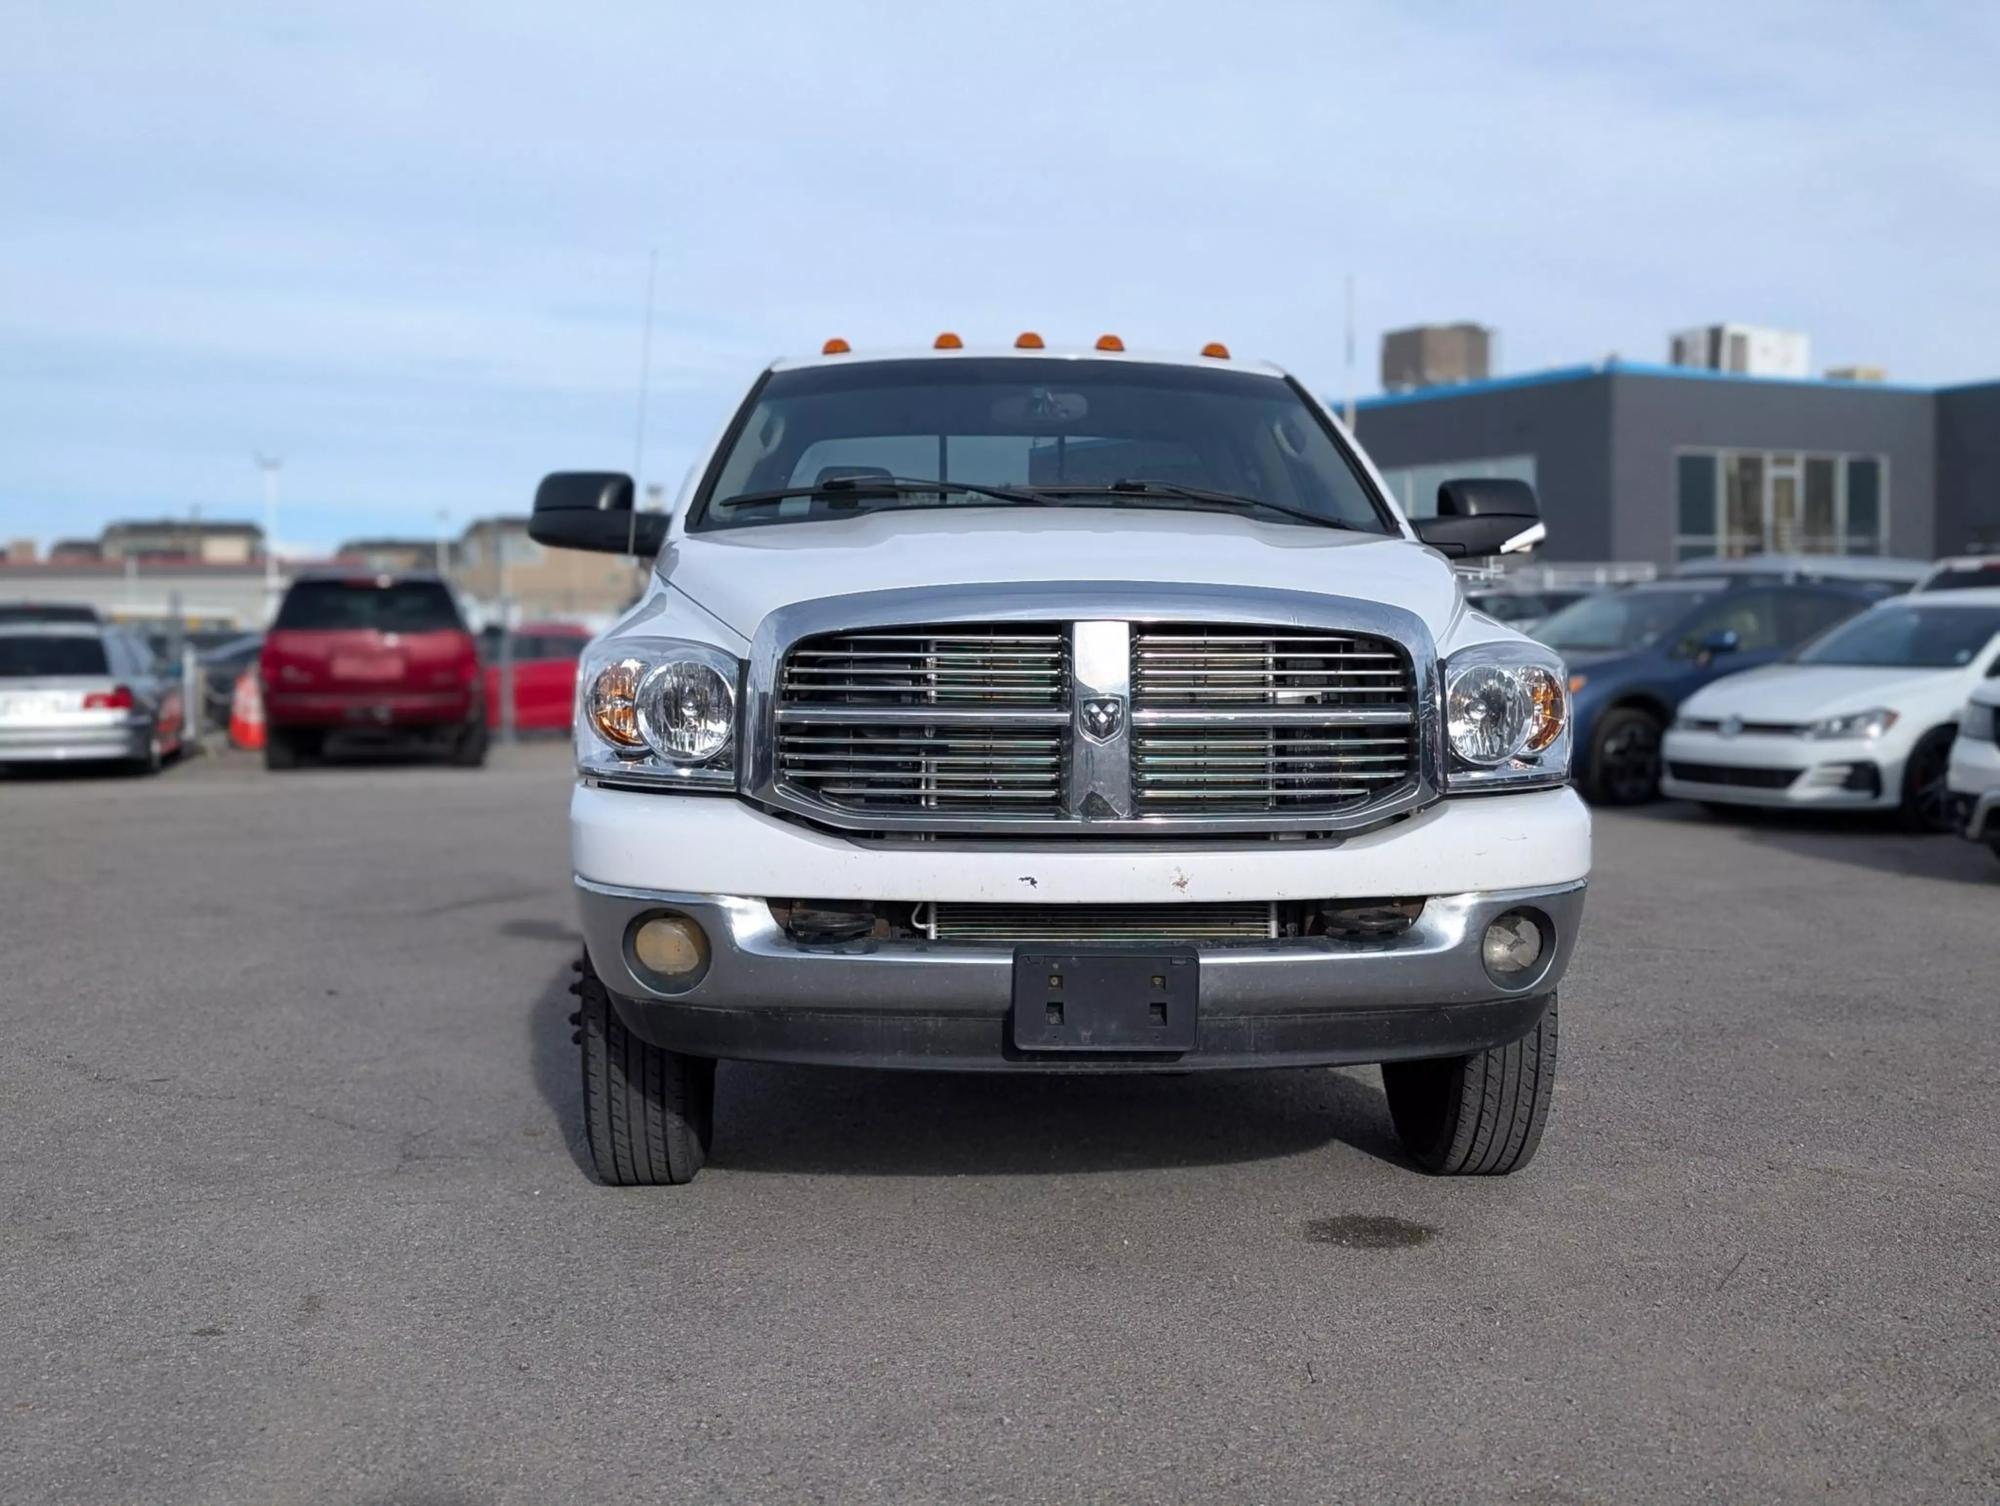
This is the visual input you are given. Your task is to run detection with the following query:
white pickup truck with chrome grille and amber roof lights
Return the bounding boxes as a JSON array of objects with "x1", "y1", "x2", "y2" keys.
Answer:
[{"x1": 530, "y1": 336, "x2": 1590, "y2": 1184}]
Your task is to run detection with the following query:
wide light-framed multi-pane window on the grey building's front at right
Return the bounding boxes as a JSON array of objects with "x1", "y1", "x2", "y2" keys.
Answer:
[{"x1": 1674, "y1": 450, "x2": 1886, "y2": 560}]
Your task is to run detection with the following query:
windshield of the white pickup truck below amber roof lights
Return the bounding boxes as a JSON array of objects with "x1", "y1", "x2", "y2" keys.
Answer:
[{"x1": 688, "y1": 358, "x2": 1390, "y2": 534}]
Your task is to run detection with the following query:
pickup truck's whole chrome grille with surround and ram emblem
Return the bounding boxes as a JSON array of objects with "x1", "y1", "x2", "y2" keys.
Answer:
[{"x1": 740, "y1": 582, "x2": 1444, "y2": 840}]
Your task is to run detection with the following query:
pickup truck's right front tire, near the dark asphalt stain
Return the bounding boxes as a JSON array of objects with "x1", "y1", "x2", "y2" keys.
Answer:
[{"x1": 1382, "y1": 996, "x2": 1556, "y2": 1176}]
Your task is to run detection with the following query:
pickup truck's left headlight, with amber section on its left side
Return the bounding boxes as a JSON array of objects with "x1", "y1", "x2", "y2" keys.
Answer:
[{"x1": 576, "y1": 638, "x2": 742, "y2": 790}]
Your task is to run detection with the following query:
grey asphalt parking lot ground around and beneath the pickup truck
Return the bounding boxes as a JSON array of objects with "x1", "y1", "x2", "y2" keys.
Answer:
[{"x1": 0, "y1": 746, "x2": 2000, "y2": 1506}]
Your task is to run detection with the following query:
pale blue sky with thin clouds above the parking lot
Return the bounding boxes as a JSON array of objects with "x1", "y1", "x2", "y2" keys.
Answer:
[{"x1": 0, "y1": 0, "x2": 2000, "y2": 548}]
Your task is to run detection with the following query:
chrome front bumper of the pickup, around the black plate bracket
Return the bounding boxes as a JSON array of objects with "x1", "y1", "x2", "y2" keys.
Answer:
[{"x1": 576, "y1": 880, "x2": 1584, "y2": 1072}]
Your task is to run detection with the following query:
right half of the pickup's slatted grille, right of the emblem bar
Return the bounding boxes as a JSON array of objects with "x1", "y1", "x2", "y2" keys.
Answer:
[{"x1": 1132, "y1": 624, "x2": 1418, "y2": 814}]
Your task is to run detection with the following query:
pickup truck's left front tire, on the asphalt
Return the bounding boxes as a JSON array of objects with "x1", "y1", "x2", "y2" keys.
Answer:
[{"x1": 576, "y1": 952, "x2": 716, "y2": 1188}]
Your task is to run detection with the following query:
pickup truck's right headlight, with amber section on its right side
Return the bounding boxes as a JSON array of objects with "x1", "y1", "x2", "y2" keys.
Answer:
[{"x1": 1444, "y1": 644, "x2": 1570, "y2": 790}]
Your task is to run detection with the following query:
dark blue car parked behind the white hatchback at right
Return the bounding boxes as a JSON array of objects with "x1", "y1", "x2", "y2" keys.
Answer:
[{"x1": 1534, "y1": 580, "x2": 1882, "y2": 806}]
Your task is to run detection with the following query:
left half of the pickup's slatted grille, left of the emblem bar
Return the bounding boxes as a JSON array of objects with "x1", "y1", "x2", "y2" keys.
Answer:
[{"x1": 776, "y1": 624, "x2": 1070, "y2": 816}]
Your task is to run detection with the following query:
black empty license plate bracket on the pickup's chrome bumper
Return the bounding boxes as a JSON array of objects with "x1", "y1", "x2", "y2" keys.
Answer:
[{"x1": 1012, "y1": 946, "x2": 1200, "y2": 1054}]
